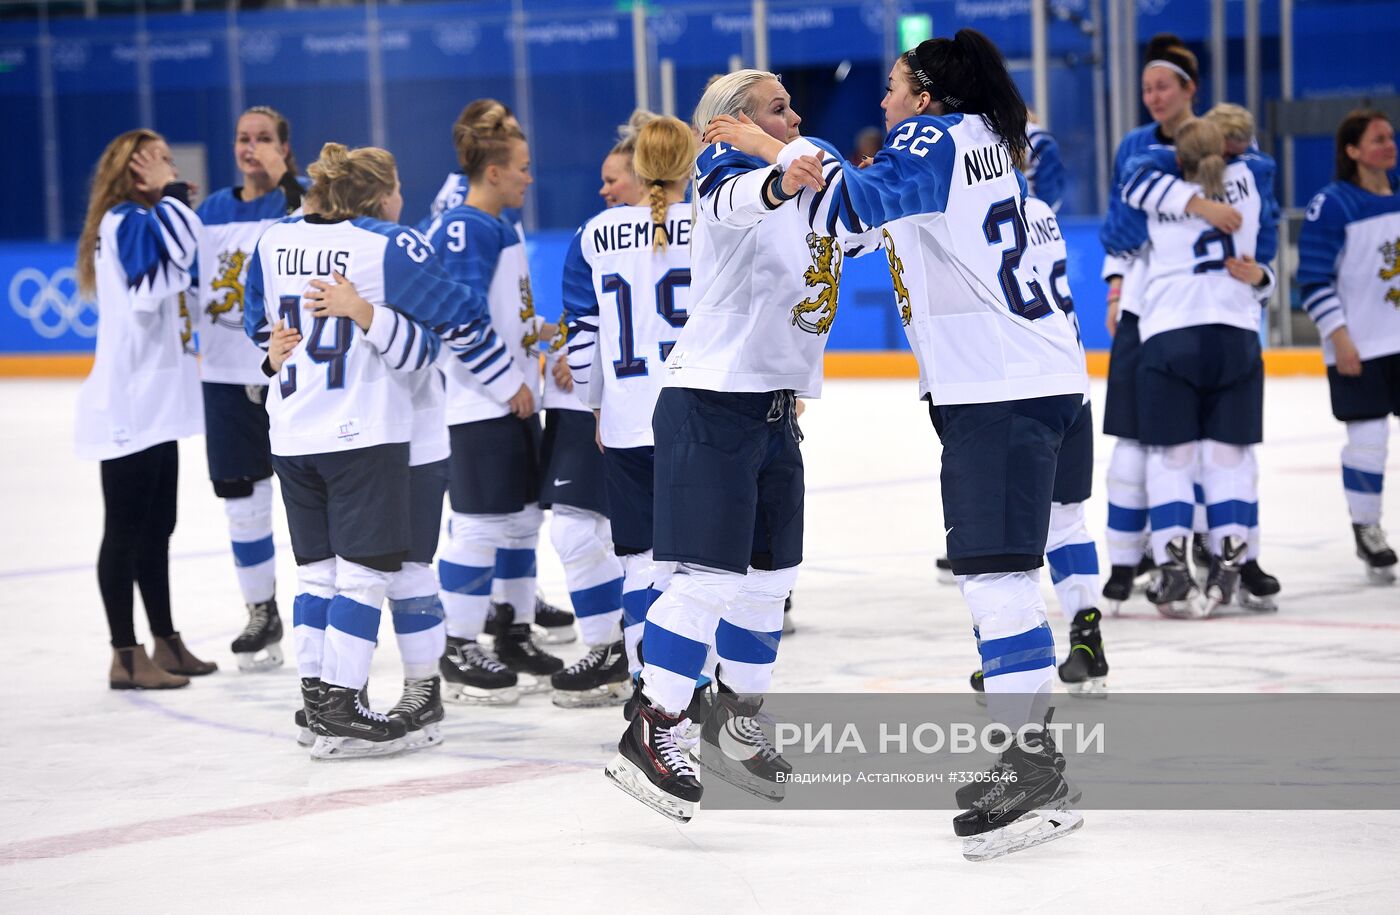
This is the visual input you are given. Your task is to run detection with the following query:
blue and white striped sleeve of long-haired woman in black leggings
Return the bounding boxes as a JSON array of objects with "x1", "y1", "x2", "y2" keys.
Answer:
[{"x1": 116, "y1": 197, "x2": 200, "y2": 312}]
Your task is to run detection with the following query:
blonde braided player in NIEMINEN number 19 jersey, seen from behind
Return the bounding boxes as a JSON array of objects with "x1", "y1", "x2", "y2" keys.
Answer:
[{"x1": 554, "y1": 118, "x2": 694, "y2": 705}]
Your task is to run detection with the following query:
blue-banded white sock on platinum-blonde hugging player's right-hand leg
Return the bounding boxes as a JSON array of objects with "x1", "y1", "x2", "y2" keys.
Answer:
[{"x1": 714, "y1": 567, "x2": 797, "y2": 694}]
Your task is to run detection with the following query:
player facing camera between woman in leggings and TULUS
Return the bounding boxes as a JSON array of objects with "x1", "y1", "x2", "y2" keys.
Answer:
[{"x1": 197, "y1": 105, "x2": 302, "y2": 672}]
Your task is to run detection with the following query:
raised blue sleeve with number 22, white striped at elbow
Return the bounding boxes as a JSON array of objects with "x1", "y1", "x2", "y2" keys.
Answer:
[{"x1": 778, "y1": 118, "x2": 956, "y2": 242}]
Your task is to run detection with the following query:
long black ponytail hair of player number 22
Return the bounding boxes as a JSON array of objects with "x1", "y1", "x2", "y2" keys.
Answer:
[{"x1": 904, "y1": 28, "x2": 1026, "y2": 168}]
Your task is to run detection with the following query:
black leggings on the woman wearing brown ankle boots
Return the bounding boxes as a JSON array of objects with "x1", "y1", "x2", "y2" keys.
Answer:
[{"x1": 97, "y1": 442, "x2": 179, "y2": 648}]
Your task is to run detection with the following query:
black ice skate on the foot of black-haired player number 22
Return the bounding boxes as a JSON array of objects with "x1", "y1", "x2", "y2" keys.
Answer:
[{"x1": 953, "y1": 718, "x2": 1084, "y2": 860}]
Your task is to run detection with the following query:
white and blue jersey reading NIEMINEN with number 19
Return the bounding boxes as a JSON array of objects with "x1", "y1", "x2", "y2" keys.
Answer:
[{"x1": 564, "y1": 203, "x2": 692, "y2": 448}]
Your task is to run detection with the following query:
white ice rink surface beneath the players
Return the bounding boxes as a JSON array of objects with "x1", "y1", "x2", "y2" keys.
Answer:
[{"x1": 0, "y1": 379, "x2": 1400, "y2": 912}]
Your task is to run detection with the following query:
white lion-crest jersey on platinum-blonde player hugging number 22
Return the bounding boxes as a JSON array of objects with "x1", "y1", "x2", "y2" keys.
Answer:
[{"x1": 665, "y1": 143, "x2": 844, "y2": 397}]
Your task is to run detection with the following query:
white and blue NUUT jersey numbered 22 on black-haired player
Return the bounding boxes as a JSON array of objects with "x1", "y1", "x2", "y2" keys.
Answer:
[{"x1": 778, "y1": 115, "x2": 1088, "y2": 404}]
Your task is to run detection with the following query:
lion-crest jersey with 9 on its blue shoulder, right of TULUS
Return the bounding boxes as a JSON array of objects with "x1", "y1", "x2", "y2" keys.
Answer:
[{"x1": 428, "y1": 206, "x2": 543, "y2": 425}]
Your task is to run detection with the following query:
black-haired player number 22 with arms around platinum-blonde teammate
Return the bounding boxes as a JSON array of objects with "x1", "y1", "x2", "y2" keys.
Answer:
[{"x1": 711, "y1": 29, "x2": 1088, "y2": 859}]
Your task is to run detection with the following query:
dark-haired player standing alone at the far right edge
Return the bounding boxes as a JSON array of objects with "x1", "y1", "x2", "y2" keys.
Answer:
[{"x1": 1298, "y1": 111, "x2": 1400, "y2": 585}]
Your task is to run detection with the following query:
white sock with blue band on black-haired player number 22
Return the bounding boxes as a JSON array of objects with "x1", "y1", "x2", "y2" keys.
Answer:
[{"x1": 958, "y1": 571, "x2": 1054, "y2": 730}]
